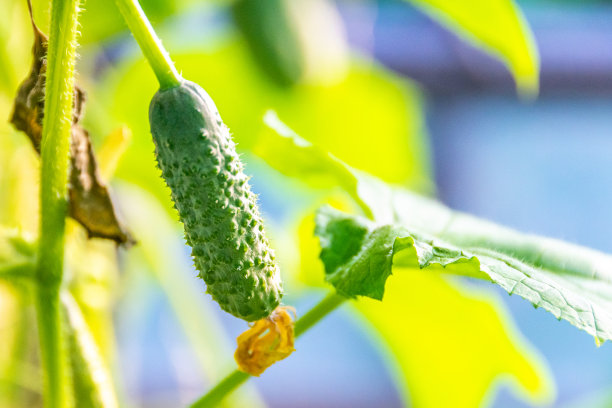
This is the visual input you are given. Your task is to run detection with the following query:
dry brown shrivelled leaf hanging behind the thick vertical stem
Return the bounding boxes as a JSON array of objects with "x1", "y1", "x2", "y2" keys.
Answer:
[{"x1": 11, "y1": 7, "x2": 131, "y2": 244}]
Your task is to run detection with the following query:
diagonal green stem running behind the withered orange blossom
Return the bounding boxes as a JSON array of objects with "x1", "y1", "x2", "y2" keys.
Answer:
[{"x1": 191, "y1": 293, "x2": 346, "y2": 408}]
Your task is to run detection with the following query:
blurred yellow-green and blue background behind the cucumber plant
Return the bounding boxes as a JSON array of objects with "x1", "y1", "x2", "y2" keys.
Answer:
[{"x1": 0, "y1": 0, "x2": 612, "y2": 407}]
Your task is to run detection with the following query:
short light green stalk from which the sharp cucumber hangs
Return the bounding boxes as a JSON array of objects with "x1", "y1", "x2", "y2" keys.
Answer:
[{"x1": 115, "y1": 0, "x2": 183, "y2": 89}]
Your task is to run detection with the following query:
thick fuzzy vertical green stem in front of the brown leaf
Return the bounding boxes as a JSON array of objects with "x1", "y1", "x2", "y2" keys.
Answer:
[{"x1": 36, "y1": 0, "x2": 79, "y2": 408}]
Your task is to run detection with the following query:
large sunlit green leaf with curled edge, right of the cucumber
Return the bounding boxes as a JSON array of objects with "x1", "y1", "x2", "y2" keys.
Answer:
[{"x1": 263, "y1": 114, "x2": 612, "y2": 342}]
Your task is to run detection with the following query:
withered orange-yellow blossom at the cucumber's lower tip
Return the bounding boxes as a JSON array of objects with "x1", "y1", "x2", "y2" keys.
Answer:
[{"x1": 234, "y1": 306, "x2": 295, "y2": 377}]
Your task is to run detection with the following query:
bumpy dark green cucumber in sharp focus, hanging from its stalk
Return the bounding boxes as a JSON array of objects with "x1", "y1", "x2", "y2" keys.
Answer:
[{"x1": 149, "y1": 81, "x2": 282, "y2": 321}]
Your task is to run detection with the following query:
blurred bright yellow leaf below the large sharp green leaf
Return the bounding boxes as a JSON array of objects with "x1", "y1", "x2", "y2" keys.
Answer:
[{"x1": 351, "y1": 268, "x2": 554, "y2": 408}]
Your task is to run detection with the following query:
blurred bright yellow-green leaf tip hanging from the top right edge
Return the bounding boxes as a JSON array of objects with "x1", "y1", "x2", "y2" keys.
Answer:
[{"x1": 408, "y1": 0, "x2": 539, "y2": 95}]
